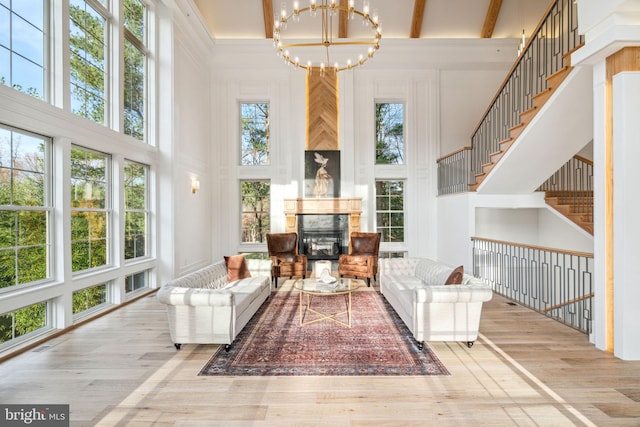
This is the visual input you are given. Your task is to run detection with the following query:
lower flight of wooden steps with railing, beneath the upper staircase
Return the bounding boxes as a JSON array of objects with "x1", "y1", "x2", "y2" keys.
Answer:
[{"x1": 538, "y1": 155, "x2": 593, "y2": 222}]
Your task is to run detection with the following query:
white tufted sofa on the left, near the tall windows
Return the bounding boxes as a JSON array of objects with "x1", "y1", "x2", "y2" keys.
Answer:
[{"x1": 158, "y1": 260, "x2": 271, "y2": 351}]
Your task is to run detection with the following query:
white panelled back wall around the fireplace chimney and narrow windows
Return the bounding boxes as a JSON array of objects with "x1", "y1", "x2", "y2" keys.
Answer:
[{"x1": 211, "y1": 40, "x2": 514, "y2": 258}]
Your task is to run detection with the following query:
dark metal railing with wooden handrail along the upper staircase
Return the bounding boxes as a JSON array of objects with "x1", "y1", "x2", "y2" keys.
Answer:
[{"x1": 438, "y1": 0, "x2": 584, "y2": 195}]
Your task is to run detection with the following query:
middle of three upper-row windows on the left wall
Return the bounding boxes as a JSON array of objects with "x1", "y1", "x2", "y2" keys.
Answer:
[{"x1": 69, "y1": 0, "x2": 108, "y2": 124}]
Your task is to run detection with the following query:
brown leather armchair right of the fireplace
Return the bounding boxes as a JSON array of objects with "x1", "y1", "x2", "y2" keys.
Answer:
[{"x1": 338, "y1": 231, "x2": 380, "y2": 286}]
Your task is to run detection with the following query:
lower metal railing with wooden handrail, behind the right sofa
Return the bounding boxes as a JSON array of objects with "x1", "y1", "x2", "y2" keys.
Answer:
[{"x1": 471, "y1": 237, "x2": 594, "y2": 334}]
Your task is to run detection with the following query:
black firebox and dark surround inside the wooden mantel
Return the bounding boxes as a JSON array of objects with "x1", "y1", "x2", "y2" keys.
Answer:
[{"x1": 298, "y1": 214, "x2": 349, "y2": 260}]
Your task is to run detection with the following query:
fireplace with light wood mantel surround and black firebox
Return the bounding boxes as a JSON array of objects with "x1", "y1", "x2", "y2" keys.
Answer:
[{"x1": 284, "y1": 198, "x2": 362, "y2": 260}]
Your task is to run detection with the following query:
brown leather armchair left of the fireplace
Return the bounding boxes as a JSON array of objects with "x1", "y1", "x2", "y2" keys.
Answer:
[{"x1": 267, "y1": 233, "x2": 307, "y2": 288}]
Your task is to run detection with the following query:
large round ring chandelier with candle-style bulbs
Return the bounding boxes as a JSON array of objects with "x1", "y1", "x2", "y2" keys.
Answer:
[{"x1": 273, "y1": 0, "x2": 382, "y2": 75}]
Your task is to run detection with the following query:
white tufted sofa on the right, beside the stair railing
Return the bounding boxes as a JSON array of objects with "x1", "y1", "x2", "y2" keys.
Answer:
[{"x1": 378, "y1": 258, "x2": 492, "y2": 348}]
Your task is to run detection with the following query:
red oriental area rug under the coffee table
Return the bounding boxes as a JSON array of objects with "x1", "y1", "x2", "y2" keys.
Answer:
[{"x1": 198, "y1": 291, "x2": 449, "y2": 376}]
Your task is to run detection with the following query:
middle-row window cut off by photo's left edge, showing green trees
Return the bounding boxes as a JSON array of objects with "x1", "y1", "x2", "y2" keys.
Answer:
[{"x1": 0, "y1": 126, "x2": 51, "y2": 288}]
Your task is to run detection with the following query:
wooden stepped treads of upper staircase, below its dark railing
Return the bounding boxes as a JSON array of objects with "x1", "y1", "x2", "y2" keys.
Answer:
[{"x1": 469, "y1": 65, "x2": 572, "y2": 191}]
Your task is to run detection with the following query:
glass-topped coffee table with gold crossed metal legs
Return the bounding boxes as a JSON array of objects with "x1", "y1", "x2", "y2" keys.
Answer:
[{"x1": 293, "y1": 278, "x2": 361, "y2": 328}]
